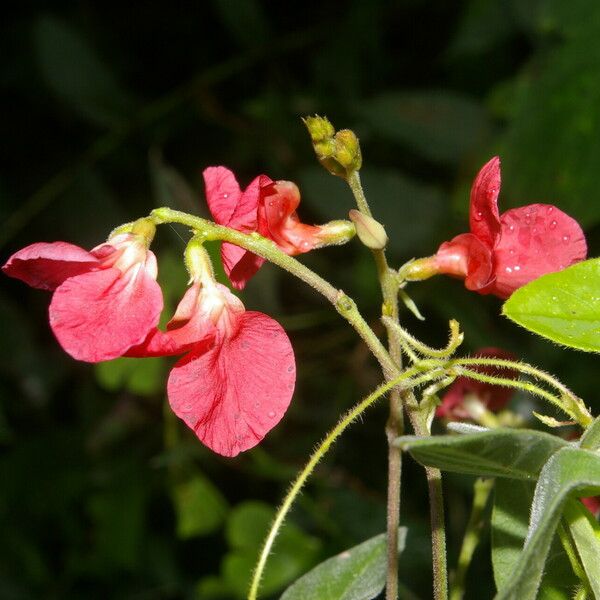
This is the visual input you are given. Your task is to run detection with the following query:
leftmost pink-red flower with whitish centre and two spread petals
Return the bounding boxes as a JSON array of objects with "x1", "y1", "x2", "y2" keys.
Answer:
[{"x1": 2, "y1": 233, "x2": 163, "y2": 362}]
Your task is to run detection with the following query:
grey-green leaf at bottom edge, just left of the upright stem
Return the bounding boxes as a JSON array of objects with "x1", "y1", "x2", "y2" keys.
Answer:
[{"x1": 281, "y1": 528, "x2": 406, "y2": 600}]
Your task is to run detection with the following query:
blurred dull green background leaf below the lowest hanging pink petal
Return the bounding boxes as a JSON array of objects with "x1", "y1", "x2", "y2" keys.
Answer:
[{"x1": 173, "y1": 473, "x2": 229, "y2": 539}]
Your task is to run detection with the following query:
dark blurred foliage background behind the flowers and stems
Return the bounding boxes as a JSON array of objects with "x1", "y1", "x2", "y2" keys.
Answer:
[{"x1": 0, "y1": 0, "x2": 600, "y2": 600}]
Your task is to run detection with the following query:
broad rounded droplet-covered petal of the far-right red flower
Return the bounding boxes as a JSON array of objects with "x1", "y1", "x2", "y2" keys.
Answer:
[{"x1": 492, "y1": 204, "x2": 587, "y2": 298}]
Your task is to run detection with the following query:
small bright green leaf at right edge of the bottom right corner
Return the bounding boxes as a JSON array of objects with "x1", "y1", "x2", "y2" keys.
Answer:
[{"x1": 564, "y1": 500, "x2": 600, "y2": 598}]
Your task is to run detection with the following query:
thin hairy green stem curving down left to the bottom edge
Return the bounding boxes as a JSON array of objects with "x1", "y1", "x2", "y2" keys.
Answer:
[{"x1": 248, "y1": 368, "x2": 431, "y2": 600}]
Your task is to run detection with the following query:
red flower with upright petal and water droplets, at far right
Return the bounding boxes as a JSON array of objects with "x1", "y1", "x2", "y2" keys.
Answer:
[{"x1": 432, "y1": 156, "x2": 587, "y2": 298}]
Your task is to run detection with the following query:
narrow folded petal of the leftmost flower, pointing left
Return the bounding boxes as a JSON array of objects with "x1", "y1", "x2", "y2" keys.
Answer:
[{"x1": 2, "y1": 242, "x2": 99, "y2": 290}]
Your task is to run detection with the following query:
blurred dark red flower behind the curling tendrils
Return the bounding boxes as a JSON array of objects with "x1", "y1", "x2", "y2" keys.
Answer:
[{"x1": 435, "y1": 347, "x2": 518, "y2": 421}]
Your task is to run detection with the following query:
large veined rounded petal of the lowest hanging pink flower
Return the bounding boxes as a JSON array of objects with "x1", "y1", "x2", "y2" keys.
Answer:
[{"x1": 167, "y1": 312, "x2": 296, "y2": 456}]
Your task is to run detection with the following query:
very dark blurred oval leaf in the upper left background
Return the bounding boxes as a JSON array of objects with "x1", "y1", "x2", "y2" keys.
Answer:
[{"x1": 33, "y1": 16, "x2": 133, "y2": 126}]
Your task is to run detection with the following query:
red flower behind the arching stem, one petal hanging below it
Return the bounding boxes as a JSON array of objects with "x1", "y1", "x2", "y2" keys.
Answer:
[{"x1": 203, "y1": 167, "x2": 325, "y2": 289}]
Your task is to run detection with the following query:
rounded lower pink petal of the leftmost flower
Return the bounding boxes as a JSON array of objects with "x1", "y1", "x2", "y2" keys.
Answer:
[{"x1": 49, "y1": 265, "x2": 163, "y2": 362}]
